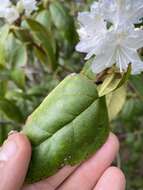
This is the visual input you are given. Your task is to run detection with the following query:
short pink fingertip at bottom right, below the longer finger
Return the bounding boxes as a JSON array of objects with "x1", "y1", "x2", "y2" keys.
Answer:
[{"x1": 94, "y1": 167, "x2": 126, "y2": 190}]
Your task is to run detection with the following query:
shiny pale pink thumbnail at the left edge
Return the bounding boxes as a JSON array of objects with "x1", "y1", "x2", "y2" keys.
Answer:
[{"x1": 0, "y1": 140, "x2": 17, "y2": 162}]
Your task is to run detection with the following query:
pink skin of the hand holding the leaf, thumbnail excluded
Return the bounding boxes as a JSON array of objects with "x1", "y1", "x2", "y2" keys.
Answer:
[{"x1": 0, "y1": 133, "x2": 126, "y2": 190}]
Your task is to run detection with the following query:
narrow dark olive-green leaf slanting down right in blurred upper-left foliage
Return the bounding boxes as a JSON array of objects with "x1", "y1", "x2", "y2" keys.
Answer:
[{"x1": 27, "y1": 19, "x2": 57, "y2": 70}]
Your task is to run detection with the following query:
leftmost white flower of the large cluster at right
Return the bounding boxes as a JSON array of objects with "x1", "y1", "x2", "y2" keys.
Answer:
[{"x1": 76, "y1": 6, "x2": 107, "y2": 59}]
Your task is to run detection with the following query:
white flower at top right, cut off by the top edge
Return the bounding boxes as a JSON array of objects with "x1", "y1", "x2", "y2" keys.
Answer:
[{"x1": 99, "y1": 0, "x2": 143, "y2": 28}]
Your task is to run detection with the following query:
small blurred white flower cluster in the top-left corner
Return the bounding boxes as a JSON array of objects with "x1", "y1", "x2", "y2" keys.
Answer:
[{"x1": 0, "y1": 0, "x2": 37, "y2": 24}]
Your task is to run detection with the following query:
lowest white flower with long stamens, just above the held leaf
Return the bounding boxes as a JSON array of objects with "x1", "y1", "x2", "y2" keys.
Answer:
[{"x1": 92, "y1": 30, "x2": 143, "y2": 74}]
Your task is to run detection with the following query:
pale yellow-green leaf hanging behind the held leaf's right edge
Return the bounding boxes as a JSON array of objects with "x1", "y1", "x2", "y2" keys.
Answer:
[{"x1": 106, "y1": 86, "x2": 126, "y2": 120}]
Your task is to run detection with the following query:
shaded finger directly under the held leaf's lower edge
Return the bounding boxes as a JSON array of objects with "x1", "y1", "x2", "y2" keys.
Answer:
[{"x1": 22, "y1": 166, "x2": 77, "y2": 190}]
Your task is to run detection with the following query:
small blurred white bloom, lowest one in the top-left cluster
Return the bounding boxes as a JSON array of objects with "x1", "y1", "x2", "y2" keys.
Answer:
[{"x1": 4, "y1": 6, "x2": 19, "y2": 24}]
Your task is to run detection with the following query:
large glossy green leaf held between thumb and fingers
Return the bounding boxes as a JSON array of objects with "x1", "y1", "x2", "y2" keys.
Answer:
[{"x1": 23, "y1": 74, "x2": 109, "y2": 183}]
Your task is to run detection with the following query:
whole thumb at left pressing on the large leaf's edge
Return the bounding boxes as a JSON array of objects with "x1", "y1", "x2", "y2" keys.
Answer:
[{"x1": 0, "y1": 133, "x2": 31, "y2": 190}]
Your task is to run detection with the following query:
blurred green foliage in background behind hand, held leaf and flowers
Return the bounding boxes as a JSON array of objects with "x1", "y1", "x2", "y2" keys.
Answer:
[{"x1": 0, "y1": 0, "x2": 143, "y2": 190}]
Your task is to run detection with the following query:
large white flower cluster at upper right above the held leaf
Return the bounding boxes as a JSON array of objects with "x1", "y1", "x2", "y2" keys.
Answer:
[{"x1": 76, "y1": 0, "x2": 143, "y2": 74}]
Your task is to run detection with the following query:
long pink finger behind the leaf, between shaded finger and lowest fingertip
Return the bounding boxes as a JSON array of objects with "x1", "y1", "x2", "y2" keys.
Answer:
[{"x1": 59, "y1": 134, "x2": 119, "y2": 190}]
